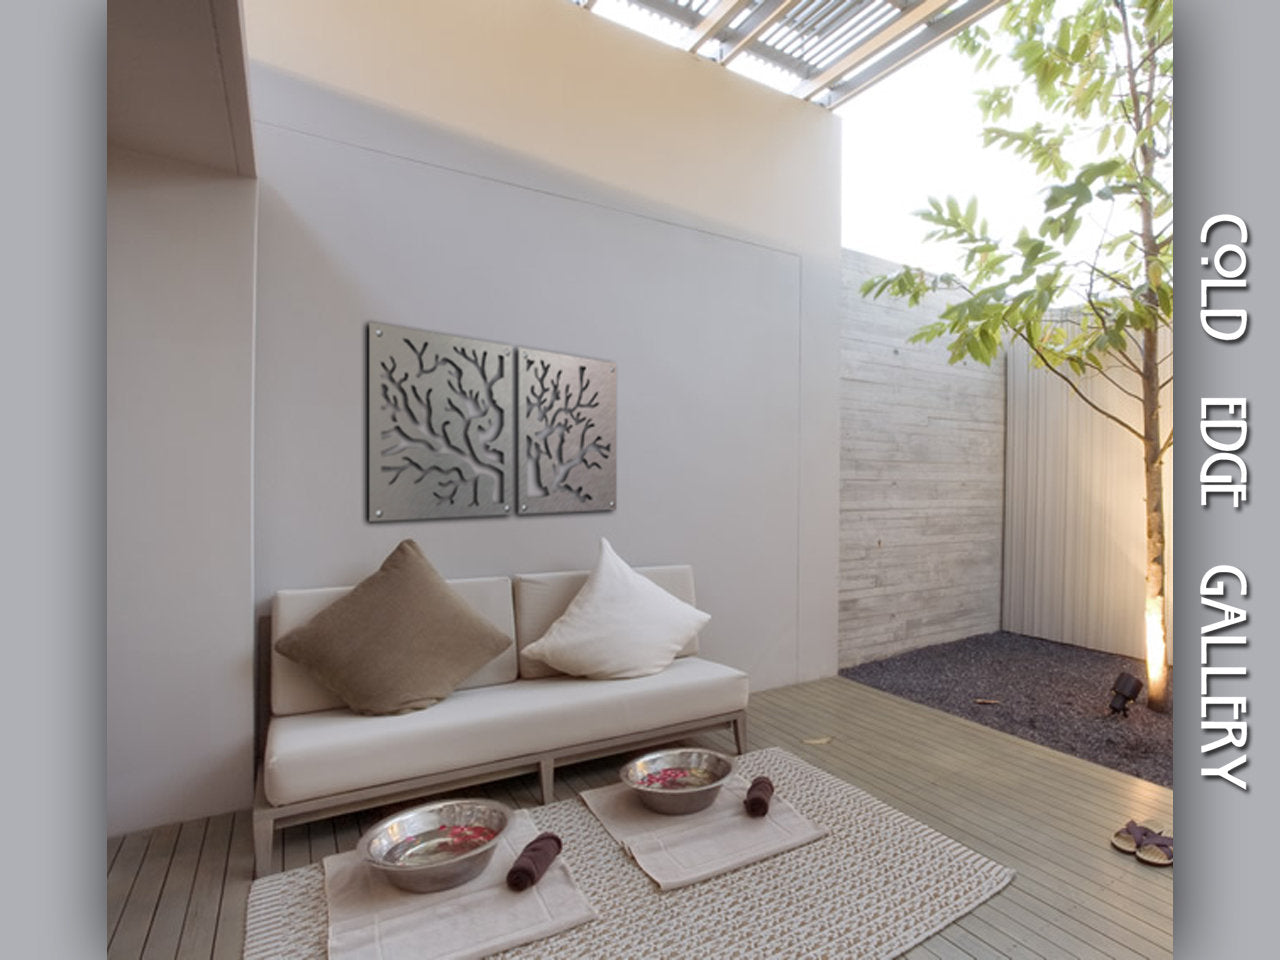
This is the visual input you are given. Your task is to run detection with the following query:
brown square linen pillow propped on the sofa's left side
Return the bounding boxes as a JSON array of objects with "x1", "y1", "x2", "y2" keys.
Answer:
[{"x1": 275, "y1": 540, "x2": 512, "y2": 713}]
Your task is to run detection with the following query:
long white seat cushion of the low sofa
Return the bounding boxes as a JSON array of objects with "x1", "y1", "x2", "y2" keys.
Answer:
[{"x1": 262, "y1": 657, "x2": 748, "y2": 805}]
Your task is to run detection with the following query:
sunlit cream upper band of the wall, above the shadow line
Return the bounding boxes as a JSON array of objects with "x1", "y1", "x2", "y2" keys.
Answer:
[{"x1": 243, "y1": 0, "x2": 840, "y2": 261}]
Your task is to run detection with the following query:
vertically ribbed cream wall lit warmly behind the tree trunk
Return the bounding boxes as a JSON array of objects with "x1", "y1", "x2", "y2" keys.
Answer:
[{"x1": 1004, "y1": 344, "x2": 1172, "y2": 659}]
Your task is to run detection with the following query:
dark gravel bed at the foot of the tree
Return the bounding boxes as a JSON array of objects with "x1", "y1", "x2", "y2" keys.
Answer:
[{"x1": 840, "y1": 631, "x2": 1174, "y2": 787}]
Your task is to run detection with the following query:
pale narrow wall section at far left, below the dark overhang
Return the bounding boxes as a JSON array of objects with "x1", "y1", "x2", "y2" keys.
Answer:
[{"x1": 106, "y1": 151, "x2": 257, "y2": 835}]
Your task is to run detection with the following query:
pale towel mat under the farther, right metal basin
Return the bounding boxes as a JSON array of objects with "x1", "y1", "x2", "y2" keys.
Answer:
[{"x1": 580, "y1": 773, "x2": 827, "y2": 890}]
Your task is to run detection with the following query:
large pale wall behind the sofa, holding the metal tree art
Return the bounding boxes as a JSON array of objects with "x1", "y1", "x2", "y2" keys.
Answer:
[{"x1": 246, "y1": 0, "x2": 840, "y2": 689}]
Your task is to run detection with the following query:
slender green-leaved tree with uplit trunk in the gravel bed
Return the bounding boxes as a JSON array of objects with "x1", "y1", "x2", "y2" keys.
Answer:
[{"x1": 861, "y1": 0, "x2": 1172, "y2": 712}]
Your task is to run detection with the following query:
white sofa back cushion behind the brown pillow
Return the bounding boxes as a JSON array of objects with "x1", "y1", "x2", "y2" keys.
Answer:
[{"x1": 271, "y1": 577, "x2": 518, "y2": 716}]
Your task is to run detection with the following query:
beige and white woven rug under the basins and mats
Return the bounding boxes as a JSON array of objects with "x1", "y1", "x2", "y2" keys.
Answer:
[{"x1": 244, "y1": 748, "x2": 1014, "y2": 960}]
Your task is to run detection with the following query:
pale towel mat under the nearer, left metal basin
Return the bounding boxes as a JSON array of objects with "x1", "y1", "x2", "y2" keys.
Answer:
[{"x1": 324, "y1": 810, "x2": 595, "y2": 960}]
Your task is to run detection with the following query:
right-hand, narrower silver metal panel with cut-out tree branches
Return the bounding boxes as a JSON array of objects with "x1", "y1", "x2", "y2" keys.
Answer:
[{"x1": 516, "y1": 347, "x2": 617, "y2": 515}]
